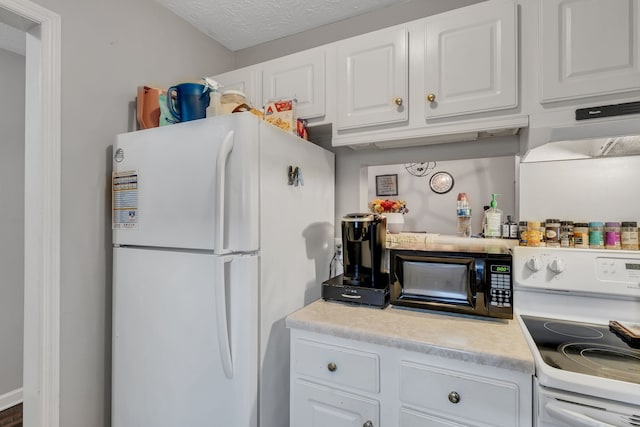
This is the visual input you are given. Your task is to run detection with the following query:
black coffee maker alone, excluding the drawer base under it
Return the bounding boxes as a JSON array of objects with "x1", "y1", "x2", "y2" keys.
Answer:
[{"x1": 342, "y1": 213, "x2": 387, "y2": 288}]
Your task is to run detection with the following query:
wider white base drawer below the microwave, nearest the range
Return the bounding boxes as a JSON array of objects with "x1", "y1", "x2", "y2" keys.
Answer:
[{"x1": 400, "y1": 362, "x2": 519, "y2": 427}]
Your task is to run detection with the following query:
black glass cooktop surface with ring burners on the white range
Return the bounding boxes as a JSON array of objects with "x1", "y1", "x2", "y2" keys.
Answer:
[{"x1": 521, "y1": 316, "x2": 640, "y2": 384}]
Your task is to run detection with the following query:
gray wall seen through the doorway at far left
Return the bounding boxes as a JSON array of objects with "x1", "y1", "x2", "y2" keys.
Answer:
[{"x1": 0, "y1": 49, "x2": 25, "y2": 402}]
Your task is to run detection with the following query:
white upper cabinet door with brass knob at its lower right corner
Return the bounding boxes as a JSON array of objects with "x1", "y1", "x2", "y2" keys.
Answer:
[{"x1": 336, "y1": 28, "x2": 408, "y2": 129}]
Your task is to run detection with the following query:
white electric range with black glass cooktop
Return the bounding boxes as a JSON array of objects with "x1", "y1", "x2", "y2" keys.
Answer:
[{"x1": 513, "y1": 247, "x2": 640, "y2": 427}]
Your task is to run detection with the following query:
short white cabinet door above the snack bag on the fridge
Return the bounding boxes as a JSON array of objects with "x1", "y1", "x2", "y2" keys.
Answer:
[{"x1": 262, "y1": 50, "x2": 325, "y2": 118}]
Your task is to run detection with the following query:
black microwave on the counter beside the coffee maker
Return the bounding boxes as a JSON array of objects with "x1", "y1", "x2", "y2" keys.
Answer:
[{"x1": 389, "y1": 249, "x2": 513, "y2": 319}]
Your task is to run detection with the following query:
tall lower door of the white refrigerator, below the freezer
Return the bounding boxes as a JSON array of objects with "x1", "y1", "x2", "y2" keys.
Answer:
[{"x1": 112, "y1": 248, "x2": 258, "y2": 427}]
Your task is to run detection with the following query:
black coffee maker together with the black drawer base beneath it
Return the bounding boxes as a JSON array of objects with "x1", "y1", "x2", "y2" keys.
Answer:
[{"x1": 322, "y1": 213, "x2": 389, "y2": 308}]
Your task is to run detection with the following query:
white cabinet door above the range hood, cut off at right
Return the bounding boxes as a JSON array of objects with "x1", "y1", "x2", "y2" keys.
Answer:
[{"x1": 539, "y1": 0, "x2": 640, "y2": 102}]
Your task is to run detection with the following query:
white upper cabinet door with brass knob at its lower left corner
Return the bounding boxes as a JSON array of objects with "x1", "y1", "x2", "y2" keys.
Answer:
[{"x1": 425, "y1": 0, "x2": 518, "y2": 119}]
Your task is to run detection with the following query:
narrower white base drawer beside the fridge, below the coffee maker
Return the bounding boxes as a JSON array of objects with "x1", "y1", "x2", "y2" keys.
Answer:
[{"x1": 294, "y1": 339, "x2": 380, "y2": 393}]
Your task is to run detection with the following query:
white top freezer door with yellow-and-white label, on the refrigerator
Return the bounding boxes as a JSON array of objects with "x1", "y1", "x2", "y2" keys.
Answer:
[{"x1": 112, "y1": 113, "x2": 260, "y2": 253}]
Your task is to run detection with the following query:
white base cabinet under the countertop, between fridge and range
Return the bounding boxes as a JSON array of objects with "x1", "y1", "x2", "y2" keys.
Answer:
[{"x1": 290, "y1": 329, "x2": 533, "y2": 427}]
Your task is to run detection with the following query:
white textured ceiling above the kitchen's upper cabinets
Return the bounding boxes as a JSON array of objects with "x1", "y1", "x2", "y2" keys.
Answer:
[{"x1": 152, "y1": 0, "x2": 408, "y2": 51}]
